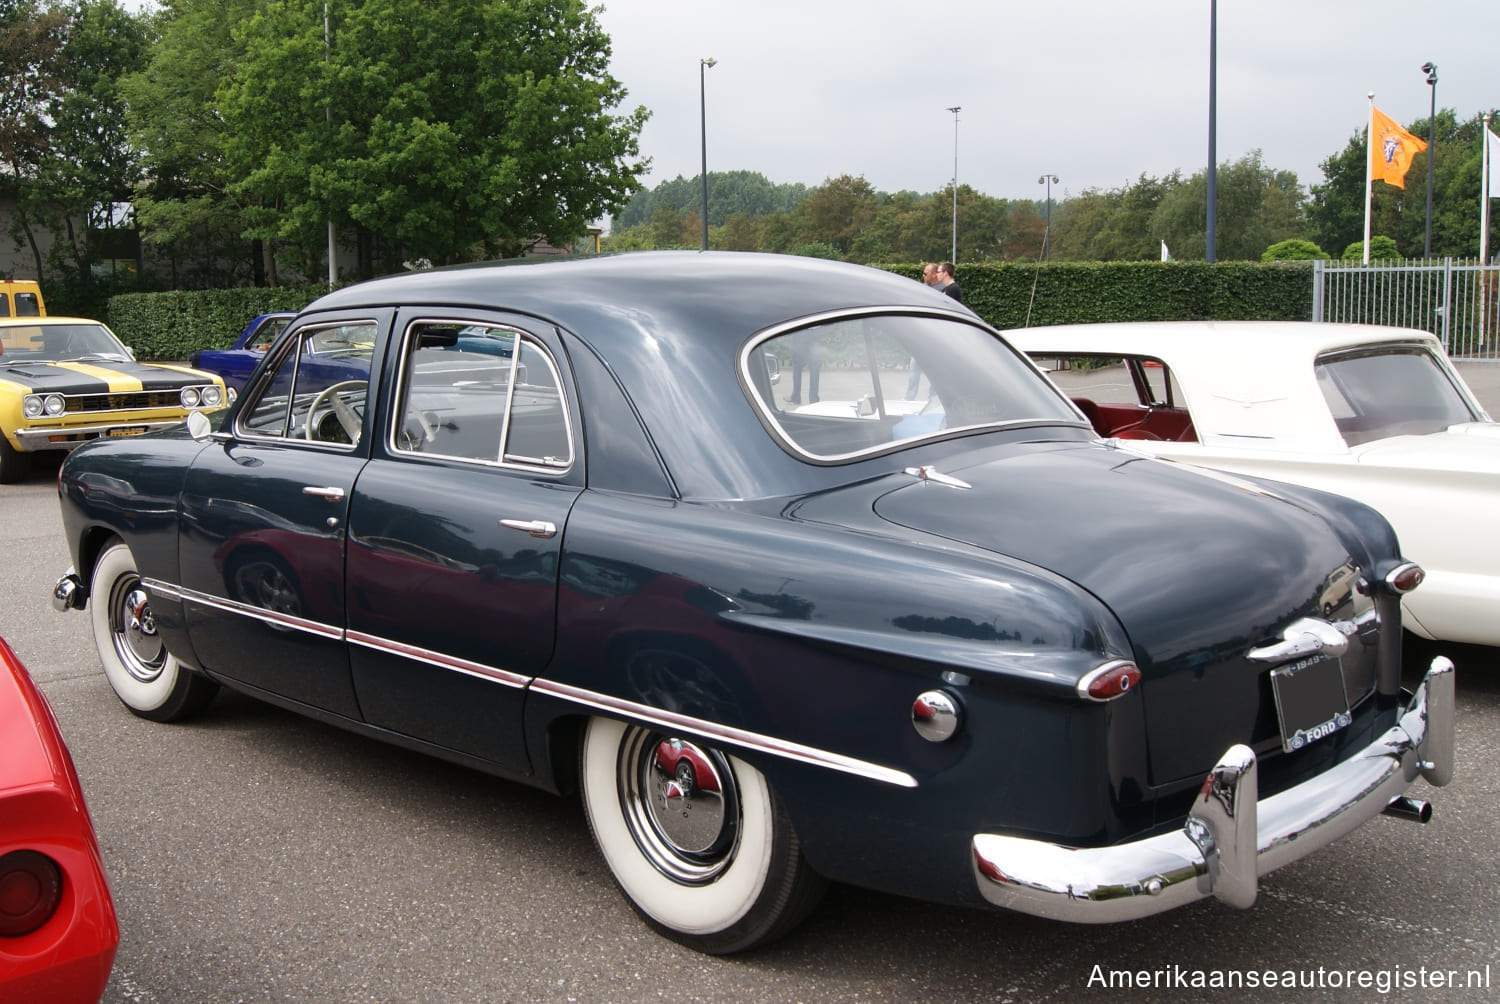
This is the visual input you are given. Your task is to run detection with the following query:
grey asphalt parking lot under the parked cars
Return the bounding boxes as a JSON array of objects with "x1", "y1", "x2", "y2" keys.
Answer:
[{"x1": 0, "y1": 365, "x2": 1500, "y2": 1004}]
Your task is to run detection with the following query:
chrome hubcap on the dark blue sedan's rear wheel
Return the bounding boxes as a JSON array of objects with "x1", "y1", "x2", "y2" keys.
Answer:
[{"x1": 618, "y1": 728, "x2": 740, "y2": 885}]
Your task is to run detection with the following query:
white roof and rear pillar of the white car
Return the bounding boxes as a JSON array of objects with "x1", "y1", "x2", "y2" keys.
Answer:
[{"x1": 1004, "y1": 321, "x2": 1458, "y2": 450}]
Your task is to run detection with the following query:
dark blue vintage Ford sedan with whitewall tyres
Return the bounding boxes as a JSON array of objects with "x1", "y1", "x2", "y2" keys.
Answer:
[{"x1": 54, "y1": 252, "x2": 1454, "y2": 953}]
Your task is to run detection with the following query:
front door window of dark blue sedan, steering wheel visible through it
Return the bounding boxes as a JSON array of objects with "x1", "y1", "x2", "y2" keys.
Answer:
[{"x1": 239, "y1": 321, "x2": 375, "y2": 447}]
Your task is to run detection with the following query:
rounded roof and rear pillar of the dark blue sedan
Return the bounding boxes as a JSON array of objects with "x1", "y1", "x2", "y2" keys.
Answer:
[{"x1": 305, "y1": 251, "x2": 983, "y2": 498}]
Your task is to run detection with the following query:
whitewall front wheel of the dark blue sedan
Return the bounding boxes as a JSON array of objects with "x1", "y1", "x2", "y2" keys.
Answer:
[{"x1": 89, "y1": 542, "x2": 219, "y2": 722}]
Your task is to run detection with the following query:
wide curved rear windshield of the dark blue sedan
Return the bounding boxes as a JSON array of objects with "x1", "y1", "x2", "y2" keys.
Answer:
[{"x1": 741, "y1": 314, "x2": 1077, "y2": 462}]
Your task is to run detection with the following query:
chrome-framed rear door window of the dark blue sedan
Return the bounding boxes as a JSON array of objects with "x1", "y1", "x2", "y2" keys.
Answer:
[{"x1": 392, "y1": 321, "x2": 573, "y2": 471}]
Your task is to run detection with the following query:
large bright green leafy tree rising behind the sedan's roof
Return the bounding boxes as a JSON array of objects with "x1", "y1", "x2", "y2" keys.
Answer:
[{"x1": 218, "y1": 0, "x2": 648, "y2": 274}]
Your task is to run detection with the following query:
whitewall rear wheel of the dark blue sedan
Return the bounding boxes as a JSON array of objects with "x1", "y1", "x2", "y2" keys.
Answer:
[{"x1": 581, "y1": 717, "x2": 825, "y2": 954}]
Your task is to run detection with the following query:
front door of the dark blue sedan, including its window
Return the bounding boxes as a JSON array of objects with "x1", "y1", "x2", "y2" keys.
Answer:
[{"x1": 179, "y1": 311, "x2": 390, "y2": 719}]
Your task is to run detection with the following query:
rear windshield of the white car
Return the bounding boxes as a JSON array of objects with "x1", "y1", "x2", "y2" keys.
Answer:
[{"x1": 1314, "y1": 347, "x2": 1479, "y2": 446}]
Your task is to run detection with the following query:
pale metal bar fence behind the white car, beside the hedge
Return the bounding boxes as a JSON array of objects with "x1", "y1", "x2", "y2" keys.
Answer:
[{"x1": 1313, "y1": 258, "x2": 1500, "y2": 362}]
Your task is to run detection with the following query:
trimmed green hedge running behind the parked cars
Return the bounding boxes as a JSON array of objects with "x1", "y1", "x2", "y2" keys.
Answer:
[{"x1": 108, "y1": 261, "x2": 1313, "y2": 359}]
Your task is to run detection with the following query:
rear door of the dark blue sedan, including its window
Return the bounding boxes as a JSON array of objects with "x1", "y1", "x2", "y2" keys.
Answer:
[{"x1": 348, "y1": 311, "x2": 584, "y2": 770}]
